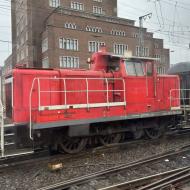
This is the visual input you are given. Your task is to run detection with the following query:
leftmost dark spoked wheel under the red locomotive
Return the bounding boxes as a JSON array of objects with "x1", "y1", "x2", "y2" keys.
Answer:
[{"x1": 59, "y1": 136, "x2": 88, "y2": 154}]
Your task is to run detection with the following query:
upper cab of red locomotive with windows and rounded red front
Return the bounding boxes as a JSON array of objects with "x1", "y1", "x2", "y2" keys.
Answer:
[{"x1": 88, "y1": 52, "x2": 157, "y2": 77}]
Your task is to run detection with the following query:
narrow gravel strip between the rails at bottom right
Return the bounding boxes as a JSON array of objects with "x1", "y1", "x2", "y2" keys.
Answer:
[{"x1": 76, "y1": 152, "x2": 190, "y2": 190}]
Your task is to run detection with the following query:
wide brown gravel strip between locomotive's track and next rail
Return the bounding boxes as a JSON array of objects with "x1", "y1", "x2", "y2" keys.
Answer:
[{"x1": 0, "y1": 135, "x2": 190, "y2": 190}]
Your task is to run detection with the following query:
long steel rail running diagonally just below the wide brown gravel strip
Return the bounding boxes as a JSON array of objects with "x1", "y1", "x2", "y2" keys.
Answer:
[{"x1": 38, "y1": 145, "x2": 190, "y2": 190}]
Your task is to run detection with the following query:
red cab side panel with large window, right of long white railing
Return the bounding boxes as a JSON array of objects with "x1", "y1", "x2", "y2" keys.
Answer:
[{"x1": 125, "y1": 59, "x2": 150, "y2": 113}]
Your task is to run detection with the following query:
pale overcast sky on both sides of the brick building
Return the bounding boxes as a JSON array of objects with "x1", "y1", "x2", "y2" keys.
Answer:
[{"x1": 0, "y1": 0, "x2": 190, "y2": 65}]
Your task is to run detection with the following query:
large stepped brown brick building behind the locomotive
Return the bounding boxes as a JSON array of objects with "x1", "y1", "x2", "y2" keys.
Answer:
[{"x1": 12, "y1": 0, "x2": 169, "y2": 73}]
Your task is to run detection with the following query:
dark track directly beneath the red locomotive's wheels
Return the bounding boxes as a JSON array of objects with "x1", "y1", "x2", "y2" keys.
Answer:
[{"x1": 0, "y1": 129, "x2": 190, "y2": 170}]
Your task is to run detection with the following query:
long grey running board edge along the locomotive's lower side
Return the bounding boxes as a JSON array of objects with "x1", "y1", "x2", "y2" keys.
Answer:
[{"x1": 33, "y1": 110, "x2": 182, "y2": 130}]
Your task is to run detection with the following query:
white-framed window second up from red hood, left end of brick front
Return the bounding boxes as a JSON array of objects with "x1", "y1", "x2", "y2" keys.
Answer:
[{"x1": 59, "y1": 38, "x2": 78, "y2": 51}]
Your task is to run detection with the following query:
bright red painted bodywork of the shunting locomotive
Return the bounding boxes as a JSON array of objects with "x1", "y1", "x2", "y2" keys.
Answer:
[{"x1": 10, "y1": 53, "x2": 180, "y2": 123}]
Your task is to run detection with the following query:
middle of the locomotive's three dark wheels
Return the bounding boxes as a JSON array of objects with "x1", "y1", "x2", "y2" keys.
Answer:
[{"x1": 99, "y1": 134, "x2": 122, "y2": 145}]
